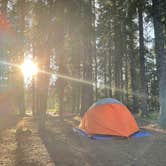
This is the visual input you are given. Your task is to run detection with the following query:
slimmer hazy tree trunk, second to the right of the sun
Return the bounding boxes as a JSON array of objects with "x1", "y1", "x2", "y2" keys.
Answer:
[{"x1": 55, "y1": 0, "x2": 68, "y2": 120}]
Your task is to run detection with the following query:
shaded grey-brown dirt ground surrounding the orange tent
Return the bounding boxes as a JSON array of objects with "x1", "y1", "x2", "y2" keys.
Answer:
[{"x1": 43, "y1": 117, "x2": 166, "y2": 166}]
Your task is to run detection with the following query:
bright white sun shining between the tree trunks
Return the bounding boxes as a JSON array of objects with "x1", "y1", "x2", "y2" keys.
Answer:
[{"x1": 21, "y1": 59, "x2": 38, "y2": 78}]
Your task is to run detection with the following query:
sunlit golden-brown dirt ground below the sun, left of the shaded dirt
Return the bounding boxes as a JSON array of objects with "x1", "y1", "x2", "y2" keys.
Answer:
[{"x1": 0, "y1": 116, "x2": 55, "y2": 166}]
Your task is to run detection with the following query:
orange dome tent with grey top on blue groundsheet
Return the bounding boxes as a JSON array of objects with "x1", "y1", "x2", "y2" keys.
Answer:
[{"x1": 79, "y1": 98, "x2": 139, "y2": 137}]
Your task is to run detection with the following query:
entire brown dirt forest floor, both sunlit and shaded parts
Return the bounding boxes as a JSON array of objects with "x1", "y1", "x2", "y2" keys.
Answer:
[{"x1": 0, "y1": 115, "x2": 166, "y2": 166}]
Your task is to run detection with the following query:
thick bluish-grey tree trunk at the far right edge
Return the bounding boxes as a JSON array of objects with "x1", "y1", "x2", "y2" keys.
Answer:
[{"x1": 152, "y1": 0, "x2": 166, "y2": 128}]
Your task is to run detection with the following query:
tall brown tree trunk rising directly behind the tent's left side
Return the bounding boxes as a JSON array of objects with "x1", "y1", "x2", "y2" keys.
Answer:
[{"x1": 81, "y1": 0, "x2": 93, "y2": 115}]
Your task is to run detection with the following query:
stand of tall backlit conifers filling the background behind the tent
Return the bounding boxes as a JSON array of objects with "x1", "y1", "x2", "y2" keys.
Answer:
[{"x1": 0, "y1": 0, "x2": 166, "y2": 127}]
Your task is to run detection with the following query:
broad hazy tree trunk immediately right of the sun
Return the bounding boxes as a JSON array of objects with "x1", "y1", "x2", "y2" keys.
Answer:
[{"x1": 33, "y1": 1, "x2": 51, "y2": 130}]
